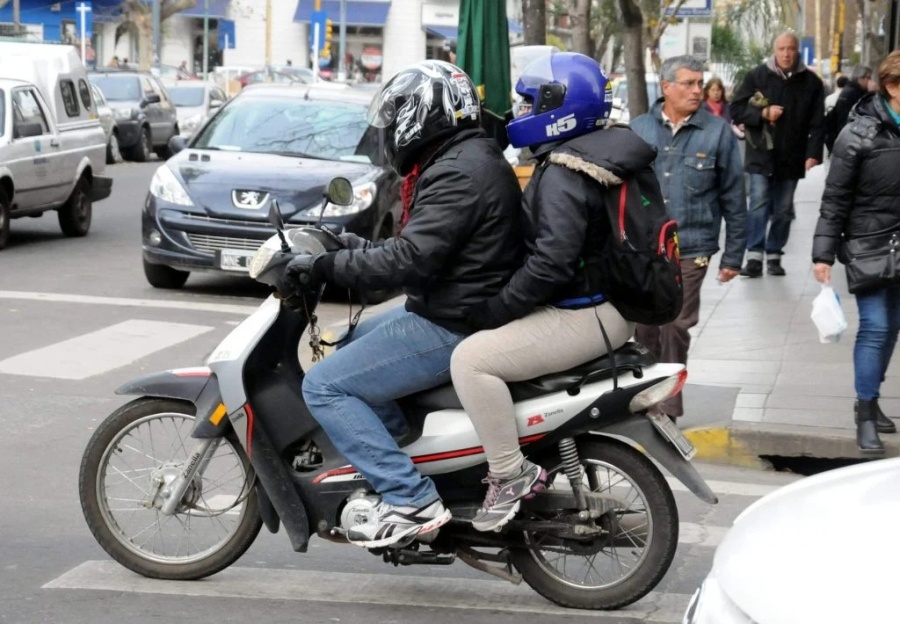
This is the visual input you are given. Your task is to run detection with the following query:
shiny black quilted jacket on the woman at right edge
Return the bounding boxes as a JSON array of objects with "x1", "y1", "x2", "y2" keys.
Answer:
[{"x1": 812, "y1": 93, "x2": 900, "y2": 264}]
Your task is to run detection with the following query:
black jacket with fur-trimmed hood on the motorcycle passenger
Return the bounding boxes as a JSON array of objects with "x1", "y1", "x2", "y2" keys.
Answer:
[{"x1": 480, "y1": 126, "x2": 656, "y2": 327}]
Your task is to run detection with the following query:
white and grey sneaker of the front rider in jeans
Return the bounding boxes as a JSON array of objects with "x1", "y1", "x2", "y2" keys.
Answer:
[{"x1": 347, "y1": 499, "x2": 451, "y2": 548}]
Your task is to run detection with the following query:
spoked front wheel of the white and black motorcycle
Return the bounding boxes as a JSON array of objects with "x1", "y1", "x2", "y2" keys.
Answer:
[{"x1": 78, "y1": 398, "x2": 262, "y2": 580}]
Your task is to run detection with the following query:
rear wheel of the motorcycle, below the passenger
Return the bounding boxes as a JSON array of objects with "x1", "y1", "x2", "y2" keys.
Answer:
[{"x1": 510, "y1": 439, "x2": 678, "y2": 610}]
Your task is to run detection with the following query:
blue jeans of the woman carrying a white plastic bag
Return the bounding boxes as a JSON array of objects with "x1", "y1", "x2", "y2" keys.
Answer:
[{"x1": 853, "y1": 286, "x2": 900, "y2": 401}]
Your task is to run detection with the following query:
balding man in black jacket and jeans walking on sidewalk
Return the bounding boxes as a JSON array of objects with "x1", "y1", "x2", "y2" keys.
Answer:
[{"x1": 731, "y1": 32, "x2": 825, "y2": 277}]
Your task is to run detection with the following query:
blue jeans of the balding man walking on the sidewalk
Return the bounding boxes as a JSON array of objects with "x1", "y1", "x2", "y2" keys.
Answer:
[{"x1": 747, "y1": 173, "x2": 797, "y2": 260}]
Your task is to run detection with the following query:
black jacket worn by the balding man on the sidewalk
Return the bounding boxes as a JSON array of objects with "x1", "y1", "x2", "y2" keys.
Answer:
[{"x1": 731, "y1": 59, "x2": 825, "y2": 180}]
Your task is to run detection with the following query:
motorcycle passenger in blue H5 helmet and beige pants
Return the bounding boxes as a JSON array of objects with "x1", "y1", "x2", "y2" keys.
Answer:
[{"x1": 451, "y1": 52, "x2": 656, "y2": 531}]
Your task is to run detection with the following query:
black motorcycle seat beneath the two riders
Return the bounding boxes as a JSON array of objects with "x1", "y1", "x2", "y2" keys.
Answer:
[{"x1": 400, "y1": 342, "x2": 656, "y2": 414}]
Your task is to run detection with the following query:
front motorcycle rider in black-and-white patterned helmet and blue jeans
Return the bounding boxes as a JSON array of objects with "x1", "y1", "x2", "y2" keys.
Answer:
[{"x1": 279, "y1": 61, "x2": 524, "y2": 548}]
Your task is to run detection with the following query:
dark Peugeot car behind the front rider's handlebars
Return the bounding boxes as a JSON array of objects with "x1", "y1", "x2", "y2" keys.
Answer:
[{"x1": 142, "y1": 83, "x2": 401, "y2": 288}]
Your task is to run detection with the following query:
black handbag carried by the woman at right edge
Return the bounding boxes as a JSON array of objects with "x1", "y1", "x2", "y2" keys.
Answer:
[{"x1": 839, "y1": 228, "x2": 900, "y2": 294}]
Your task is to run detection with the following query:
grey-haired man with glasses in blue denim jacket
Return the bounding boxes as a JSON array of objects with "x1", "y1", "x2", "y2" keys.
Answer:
[{"x1": 631, "y1": 56, "x2": 747, "y2": 418}]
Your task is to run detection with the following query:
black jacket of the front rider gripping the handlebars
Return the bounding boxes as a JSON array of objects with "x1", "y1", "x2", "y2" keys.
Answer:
[{"x1": 320, "y1": 130, "x2": 524, "y2": 333}]
